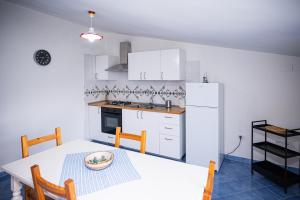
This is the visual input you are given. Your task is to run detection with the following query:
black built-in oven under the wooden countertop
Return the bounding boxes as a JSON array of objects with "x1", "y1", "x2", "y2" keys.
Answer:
[{"x1": 101, "y1": 107, "x2": 122, "y2": 135}]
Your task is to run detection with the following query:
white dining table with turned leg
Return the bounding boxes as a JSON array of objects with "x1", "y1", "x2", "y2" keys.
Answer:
[{"x1": 1, "y1": 140, "x2": 208, "y2": 200}]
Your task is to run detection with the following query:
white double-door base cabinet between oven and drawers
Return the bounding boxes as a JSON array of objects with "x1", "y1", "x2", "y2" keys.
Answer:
[{"x1": 121, "y1": 109, "x2": 159, "y2": 154}]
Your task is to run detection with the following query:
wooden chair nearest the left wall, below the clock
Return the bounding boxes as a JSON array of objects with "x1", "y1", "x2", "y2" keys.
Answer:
[{"x1": 21, "y1": 127, "x2": 62, "y2": 200}]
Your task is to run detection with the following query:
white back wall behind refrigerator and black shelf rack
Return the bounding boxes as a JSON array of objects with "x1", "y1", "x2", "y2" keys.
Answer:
[{"x1": 85, "y1": 30, "x2": 300, "y2": 166}]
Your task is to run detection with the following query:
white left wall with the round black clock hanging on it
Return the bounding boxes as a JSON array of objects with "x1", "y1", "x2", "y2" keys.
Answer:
[{"x1": 0, "y1": 1, "x2": 87, "y2": 166}]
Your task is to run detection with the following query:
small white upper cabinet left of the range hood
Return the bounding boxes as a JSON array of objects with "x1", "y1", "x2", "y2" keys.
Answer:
[{"x1": 95, "y1": 55, "x2": 119, "y2": 80}]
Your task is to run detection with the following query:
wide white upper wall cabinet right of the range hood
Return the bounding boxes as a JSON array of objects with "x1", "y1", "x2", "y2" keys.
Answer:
[{"x1": 128, "y1": 49, "x2": 185, "y2": 80}]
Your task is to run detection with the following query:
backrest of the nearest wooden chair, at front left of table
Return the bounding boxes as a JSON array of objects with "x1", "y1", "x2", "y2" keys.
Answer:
[{"x1": 31, "y1": 165, "x2": 76, "y2": 200}]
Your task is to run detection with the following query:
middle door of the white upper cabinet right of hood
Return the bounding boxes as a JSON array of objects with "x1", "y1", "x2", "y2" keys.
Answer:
[{"x1": 142, "y1": 51, "x2": 161, "y2": 80}]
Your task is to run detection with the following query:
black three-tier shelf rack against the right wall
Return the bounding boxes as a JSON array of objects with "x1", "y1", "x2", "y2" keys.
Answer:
[{"x1": 251, "y1": 120, "x2": 300, "y2": 193}]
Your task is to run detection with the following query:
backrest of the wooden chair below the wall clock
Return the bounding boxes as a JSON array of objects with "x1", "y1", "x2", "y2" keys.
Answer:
[{"x1": 21, "y1": 127, "x2": 61, "y2": 158}]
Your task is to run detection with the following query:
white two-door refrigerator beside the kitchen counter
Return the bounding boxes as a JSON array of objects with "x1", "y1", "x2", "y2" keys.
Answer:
[{"x1": 186, "y1": 83, "x2": 224, "y2": 170}]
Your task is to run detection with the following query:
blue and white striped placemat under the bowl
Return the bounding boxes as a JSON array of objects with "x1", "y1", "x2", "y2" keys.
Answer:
[{"x1": 60, "y1": 149, "x2": 141, "y2": 196}]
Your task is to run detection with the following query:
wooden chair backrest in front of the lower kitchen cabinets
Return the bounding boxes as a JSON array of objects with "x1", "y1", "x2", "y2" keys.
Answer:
[{"x1": 115, "y1": 127, "x2": 146, "y2": 153}]
